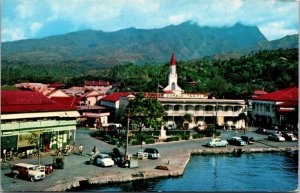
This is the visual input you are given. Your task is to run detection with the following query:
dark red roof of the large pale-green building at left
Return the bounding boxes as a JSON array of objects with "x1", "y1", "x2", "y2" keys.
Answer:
[{"x1": 1, "y1": 90, "x2": 74, "y2": 113}]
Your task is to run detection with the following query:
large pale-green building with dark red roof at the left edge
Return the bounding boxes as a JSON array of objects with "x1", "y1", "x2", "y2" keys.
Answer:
[{"x1": 1, "y1": 90, "x2": 80, "y2": 153}]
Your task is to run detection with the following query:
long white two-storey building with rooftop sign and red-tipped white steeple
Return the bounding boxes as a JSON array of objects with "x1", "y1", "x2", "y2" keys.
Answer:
[{"x1": 149, "y1": 53, "x2": 247, "y2": 128}]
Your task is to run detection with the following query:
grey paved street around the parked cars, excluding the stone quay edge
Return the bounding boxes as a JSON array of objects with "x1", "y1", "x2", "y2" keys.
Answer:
[{"x1": 1, "y1": 126, "x2": 298, "y2": 191}]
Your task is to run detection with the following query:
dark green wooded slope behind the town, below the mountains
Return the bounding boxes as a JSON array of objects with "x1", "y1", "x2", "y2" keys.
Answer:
[{"x1": 1, "y1": 49, "x2": 298, "y2": 99}]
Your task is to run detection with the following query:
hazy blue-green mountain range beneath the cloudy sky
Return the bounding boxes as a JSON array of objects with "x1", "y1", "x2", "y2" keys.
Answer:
[{"x1": 2, "y1": 21, "x2": 298, "y2": 67}]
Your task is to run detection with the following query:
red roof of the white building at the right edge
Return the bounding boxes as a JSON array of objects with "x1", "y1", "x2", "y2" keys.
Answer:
[{"x1": 255, "y1": 87, "x2": 298, "y2": 101}]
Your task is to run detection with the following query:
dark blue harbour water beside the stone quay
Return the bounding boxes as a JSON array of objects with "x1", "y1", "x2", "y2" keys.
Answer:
[{"x1": 77, "y1": 153, "x2": 298, "y2": 192}]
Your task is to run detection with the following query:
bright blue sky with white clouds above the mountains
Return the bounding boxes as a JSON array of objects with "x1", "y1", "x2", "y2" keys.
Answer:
[{"x1": 1, "y1": 0, "x2": 299, "y2": 42}]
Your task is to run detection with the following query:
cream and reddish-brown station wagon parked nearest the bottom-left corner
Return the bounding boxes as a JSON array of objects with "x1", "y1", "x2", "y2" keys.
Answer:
[{"x1": 11, "y1": 163, "x2": 45, "y2": 182}]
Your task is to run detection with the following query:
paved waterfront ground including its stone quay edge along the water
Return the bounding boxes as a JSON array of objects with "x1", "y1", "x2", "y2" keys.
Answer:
[{"x1": 1, "y1": 129, "x2": 298, "y2": 192}]
